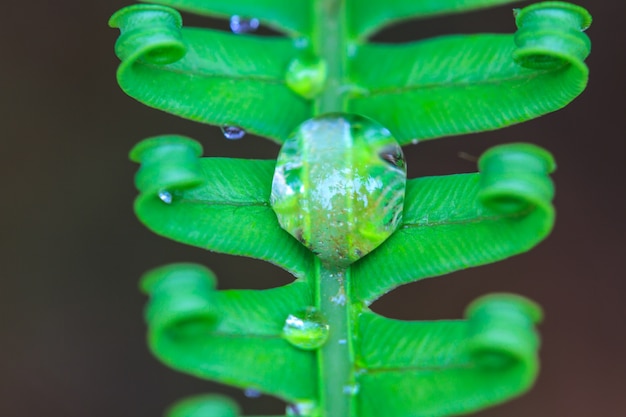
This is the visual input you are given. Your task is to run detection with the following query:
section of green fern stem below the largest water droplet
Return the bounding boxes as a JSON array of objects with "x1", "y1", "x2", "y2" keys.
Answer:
[{"x1": 316, "y1": 260, "x2": 358, "y2": 417}]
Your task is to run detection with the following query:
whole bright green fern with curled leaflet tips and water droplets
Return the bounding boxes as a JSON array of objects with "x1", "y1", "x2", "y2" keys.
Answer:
[{"x1": 110, "y1": 0, "x2": 591, "y2": 417}]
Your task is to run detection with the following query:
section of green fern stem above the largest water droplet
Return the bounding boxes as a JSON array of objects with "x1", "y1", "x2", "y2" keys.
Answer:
[{"x1": 312, "y1": 0, "x2": 348, "y2": 115}]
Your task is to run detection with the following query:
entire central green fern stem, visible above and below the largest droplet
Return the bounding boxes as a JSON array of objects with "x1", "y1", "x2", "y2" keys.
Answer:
[{"x1": 312, "y1": 0, "x2": 358, "y2": 417}]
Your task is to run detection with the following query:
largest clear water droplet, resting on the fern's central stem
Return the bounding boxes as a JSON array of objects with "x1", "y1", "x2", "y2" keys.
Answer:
[{"x1": 270, "y1": 114, "x2": 406, "y2": 266}]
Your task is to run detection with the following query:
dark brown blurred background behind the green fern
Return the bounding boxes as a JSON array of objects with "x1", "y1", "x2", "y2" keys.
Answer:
[{"x1": 0, "y1": 0, "x2": 626, "y2": 417}]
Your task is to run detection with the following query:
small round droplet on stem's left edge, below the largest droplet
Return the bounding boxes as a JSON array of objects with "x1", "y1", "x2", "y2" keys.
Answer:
[{"x1": 283, "y1": 307, "x2": 330, "y2": 350}]
